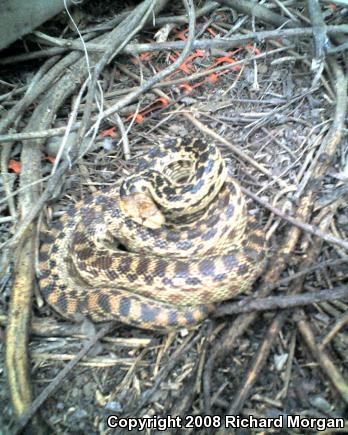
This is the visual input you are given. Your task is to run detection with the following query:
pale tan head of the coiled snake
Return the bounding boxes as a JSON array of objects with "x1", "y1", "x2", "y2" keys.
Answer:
[{"x1": 120, "y1": 192, "x2": 165, "y2": 230}]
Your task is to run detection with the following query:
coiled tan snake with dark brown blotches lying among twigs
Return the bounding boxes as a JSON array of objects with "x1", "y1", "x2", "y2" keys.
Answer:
[{"x1": 39, "y1": 137, "x2": 268, "y2": 331}]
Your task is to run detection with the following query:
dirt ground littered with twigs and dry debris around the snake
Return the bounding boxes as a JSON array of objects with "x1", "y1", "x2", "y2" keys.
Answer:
[{"x1": 0, "y1": 0, "x2": 348, "y2": 435}]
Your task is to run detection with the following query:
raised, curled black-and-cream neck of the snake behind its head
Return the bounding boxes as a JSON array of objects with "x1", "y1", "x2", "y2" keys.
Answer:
[{"x1": 120, "y1": 140, "x2": 227, "y2": 220}]
